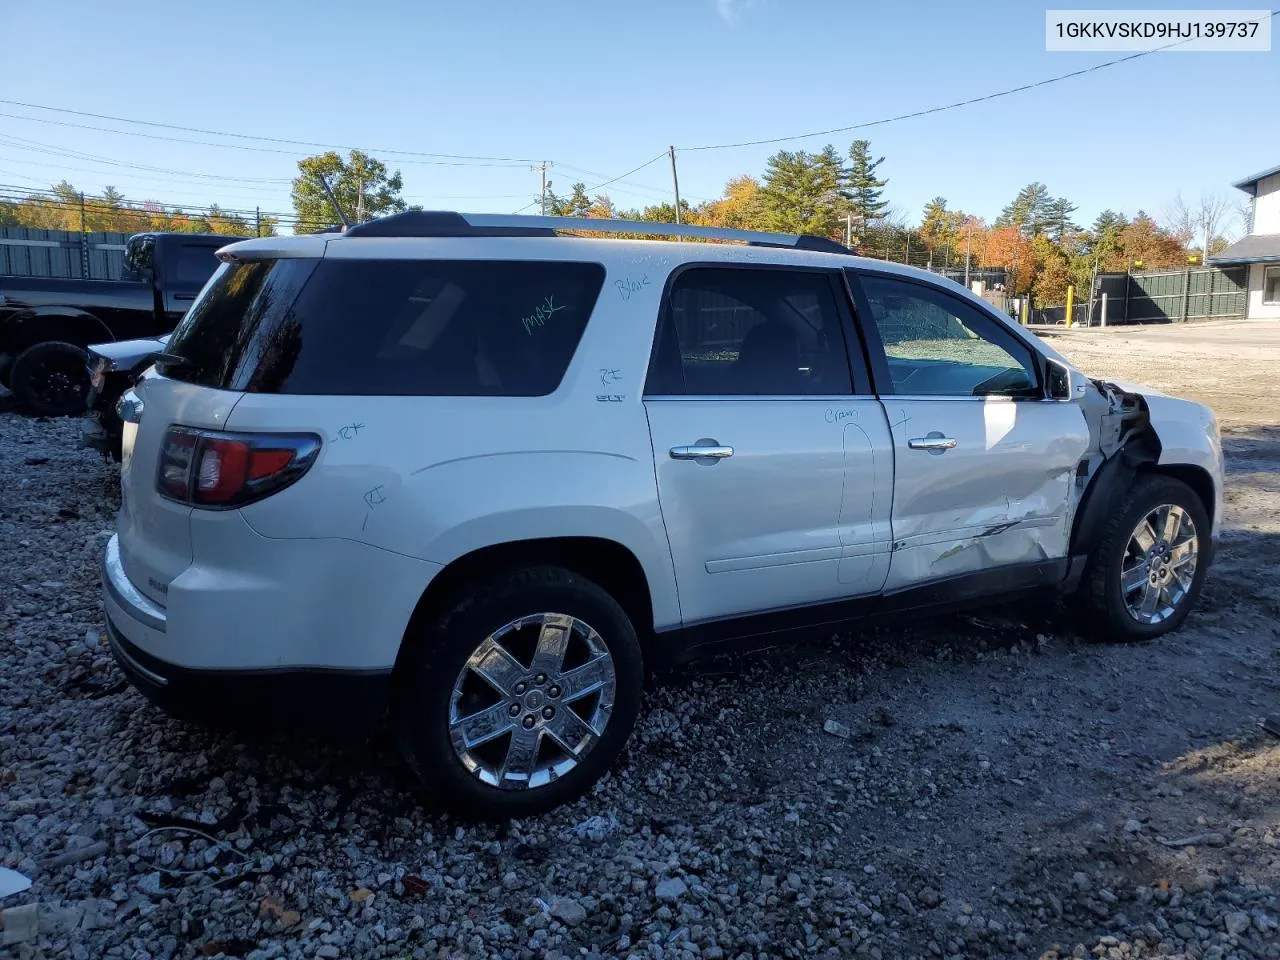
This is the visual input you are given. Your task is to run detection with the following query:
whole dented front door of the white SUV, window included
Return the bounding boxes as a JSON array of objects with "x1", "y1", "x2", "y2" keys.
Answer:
[{"x1": 847, "y1": 270, "x2": 1089, "y2": 593}]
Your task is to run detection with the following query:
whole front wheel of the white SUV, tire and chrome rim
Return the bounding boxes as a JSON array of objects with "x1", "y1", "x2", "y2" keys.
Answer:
[{"x1": 1080, "y1": 474, "x2": 1210, "y2": 641}]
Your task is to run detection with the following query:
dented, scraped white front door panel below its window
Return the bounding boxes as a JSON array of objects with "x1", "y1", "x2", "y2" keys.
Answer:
[{"x1": 884, "y1": 398, "x2": 1089, "y2": 591}]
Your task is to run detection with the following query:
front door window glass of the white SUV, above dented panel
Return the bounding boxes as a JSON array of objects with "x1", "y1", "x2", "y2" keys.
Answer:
[{"x1": 858, "y1": 275, "x2": 1041, "y2": 397}]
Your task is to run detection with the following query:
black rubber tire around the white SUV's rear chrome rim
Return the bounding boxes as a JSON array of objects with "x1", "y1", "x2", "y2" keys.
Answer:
[{"x1": 392, "y1": 567, "x2": 644, "y2": 820}]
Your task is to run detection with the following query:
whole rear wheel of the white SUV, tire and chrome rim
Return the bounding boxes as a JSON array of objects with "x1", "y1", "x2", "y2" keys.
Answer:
[{"x1": 392, "y1": 567, "x2": 644, "y2": 819}]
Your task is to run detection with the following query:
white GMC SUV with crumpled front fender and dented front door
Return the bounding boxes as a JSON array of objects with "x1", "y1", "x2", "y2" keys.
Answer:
[{"x1": 104, "y1": 212, "x2": 1222, "y2": 817}]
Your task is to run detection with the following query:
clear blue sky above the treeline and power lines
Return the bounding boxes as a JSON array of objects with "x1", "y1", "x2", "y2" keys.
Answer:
[{"x1": 0, "y1": 0, "x2": 1280, "y2": 232}]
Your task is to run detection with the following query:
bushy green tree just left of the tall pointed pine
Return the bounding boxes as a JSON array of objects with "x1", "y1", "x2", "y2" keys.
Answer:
[{"x1": 760, "y1": 145, "x2": 850, "y2": 237}]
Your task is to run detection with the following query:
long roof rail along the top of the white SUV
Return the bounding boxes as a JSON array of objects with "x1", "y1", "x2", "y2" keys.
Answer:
[{"x1": 344, "y1": 210, "x2": 852, "y2": 255}]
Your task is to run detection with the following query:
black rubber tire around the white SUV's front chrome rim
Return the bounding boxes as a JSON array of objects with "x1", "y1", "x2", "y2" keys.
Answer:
[{"x1": 1080, "y1": 474, "x2": 1210, "y2": 643}]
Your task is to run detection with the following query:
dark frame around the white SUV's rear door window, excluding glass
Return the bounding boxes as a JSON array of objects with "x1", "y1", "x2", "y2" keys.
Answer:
[{"x1": 641, "y1": 260, "x2": 876, "y2": 402}]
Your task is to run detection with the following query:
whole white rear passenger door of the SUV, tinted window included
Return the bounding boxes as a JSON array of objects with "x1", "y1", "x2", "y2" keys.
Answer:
[{"x1": 645, "y1": 265, "x2": 892, "y2": 625}]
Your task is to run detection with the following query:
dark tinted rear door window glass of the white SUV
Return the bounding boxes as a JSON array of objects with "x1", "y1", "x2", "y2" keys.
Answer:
[{"x1": 645, "y1": 266, "x2": 852, "y2": 397}]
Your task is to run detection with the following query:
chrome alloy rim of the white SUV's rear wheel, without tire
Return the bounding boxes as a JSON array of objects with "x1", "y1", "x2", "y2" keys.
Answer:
[{"x1": 449, "y1": 613, "x2": 616, "y2": 790}]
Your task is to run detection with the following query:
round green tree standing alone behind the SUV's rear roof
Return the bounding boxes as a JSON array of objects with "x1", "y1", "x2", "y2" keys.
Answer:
[{"x1": 293, "y1": 150, "x2": 406, "y2": 233}]
